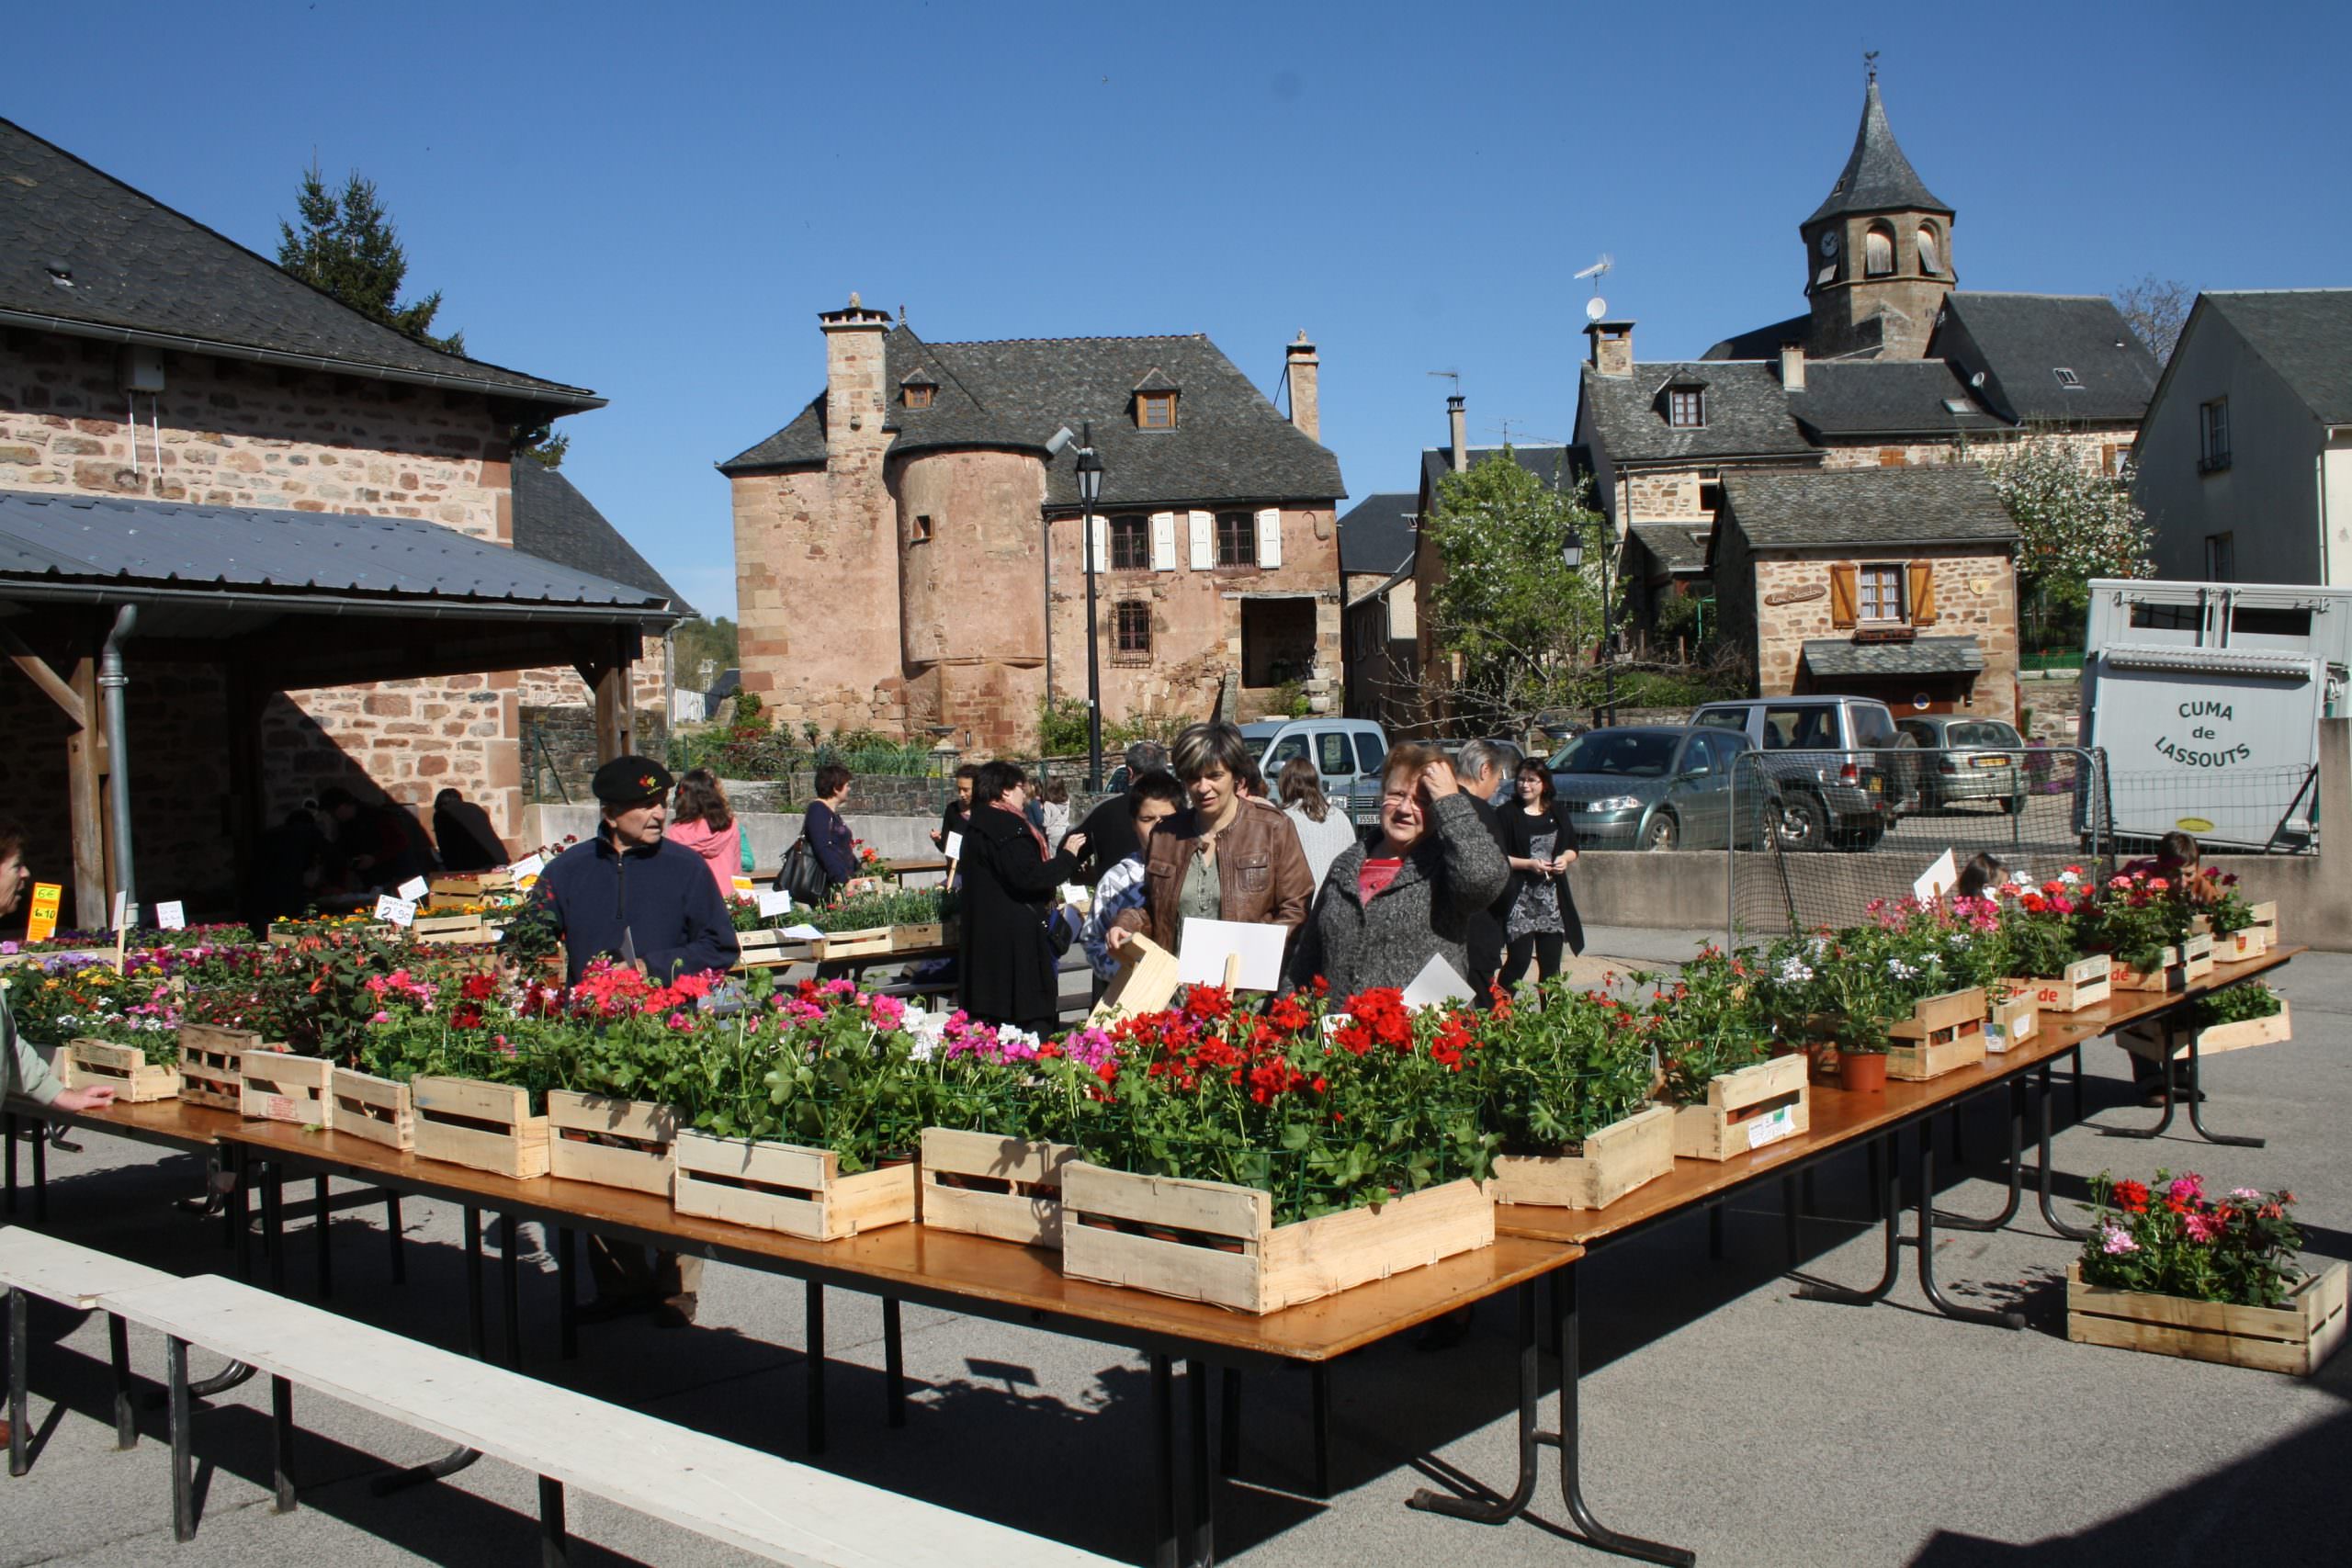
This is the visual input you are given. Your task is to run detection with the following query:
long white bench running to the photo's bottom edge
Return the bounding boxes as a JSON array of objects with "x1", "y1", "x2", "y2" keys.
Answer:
[{"x1": 101, "y1": 1274, "x2": 1110, "y2": 1568}]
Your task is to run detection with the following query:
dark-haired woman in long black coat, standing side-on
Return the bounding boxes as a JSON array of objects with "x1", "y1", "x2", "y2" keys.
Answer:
[{"x1": 957, "y1": 761, "x2": 1087, "y2": 1037}]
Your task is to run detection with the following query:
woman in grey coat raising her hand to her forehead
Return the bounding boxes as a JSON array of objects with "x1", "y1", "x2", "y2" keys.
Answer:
[{"x1": 1291, "y1": 745, "x2": 1510, "y2": 999}]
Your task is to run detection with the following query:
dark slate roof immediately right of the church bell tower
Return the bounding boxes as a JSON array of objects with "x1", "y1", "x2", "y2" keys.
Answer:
[{"x1": 1927, "y1": 289, "x2": 2159, "y2": 425}]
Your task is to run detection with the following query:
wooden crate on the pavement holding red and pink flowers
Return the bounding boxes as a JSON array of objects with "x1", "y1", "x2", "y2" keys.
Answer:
[{"x1": 2065, "y1": 1262, "x2": 2352, "y2": 1375}]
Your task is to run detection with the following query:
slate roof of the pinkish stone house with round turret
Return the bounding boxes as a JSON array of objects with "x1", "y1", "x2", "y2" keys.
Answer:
[{"x1": 719, "y1": 327, "x2": 1348, "y2": 508}]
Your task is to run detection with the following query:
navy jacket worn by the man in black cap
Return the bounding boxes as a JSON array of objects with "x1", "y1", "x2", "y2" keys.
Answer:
[{"x1": 537, "y1": 829, "x2": 741, "y2": 983}]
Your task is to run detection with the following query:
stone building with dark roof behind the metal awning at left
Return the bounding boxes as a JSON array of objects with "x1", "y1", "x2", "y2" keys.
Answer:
[{"x1": 0, "y1": 120, "x2": 673, "y2": 884}]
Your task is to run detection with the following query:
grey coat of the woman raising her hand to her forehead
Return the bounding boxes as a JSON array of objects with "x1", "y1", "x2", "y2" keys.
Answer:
[{"x1": 1291, "y1": 795, "x2": 1510, "y2": 999}]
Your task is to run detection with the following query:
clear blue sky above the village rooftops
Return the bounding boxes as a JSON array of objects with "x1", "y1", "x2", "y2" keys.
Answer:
[{"x1": 0, "y1": 0, "x2": 2352, "y2": 614}]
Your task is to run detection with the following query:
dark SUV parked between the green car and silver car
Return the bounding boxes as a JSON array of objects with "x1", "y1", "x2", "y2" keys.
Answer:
[{"x1": 1691, "y1": 696, "x2": 1917, "y2": 849}]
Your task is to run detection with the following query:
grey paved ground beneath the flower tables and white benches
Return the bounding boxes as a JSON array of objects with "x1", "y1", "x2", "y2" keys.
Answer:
[{"x1": 0, "y1": 931, "x2": 2352, "y2": 1568}]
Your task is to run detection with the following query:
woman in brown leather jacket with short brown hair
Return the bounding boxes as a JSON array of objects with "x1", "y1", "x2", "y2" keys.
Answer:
[{"x1": 1105, "y1": 724, "x2": 1315, "y2": 952}]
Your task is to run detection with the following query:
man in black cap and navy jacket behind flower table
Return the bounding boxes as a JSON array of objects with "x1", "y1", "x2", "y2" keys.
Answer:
[{"x1": 534, "y1": 757, "x2": 739, "y2": 1328}]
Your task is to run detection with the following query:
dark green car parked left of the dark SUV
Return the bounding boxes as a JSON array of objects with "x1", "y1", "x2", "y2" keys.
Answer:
[{"x1": 1550, "y1": 724, "x2": 1778, "y2": 849}]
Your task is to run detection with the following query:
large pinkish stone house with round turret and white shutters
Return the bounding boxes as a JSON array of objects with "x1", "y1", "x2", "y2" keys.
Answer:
[{"x1": 719, "y1": 296, "x2": 1345, "y2": 752}]
